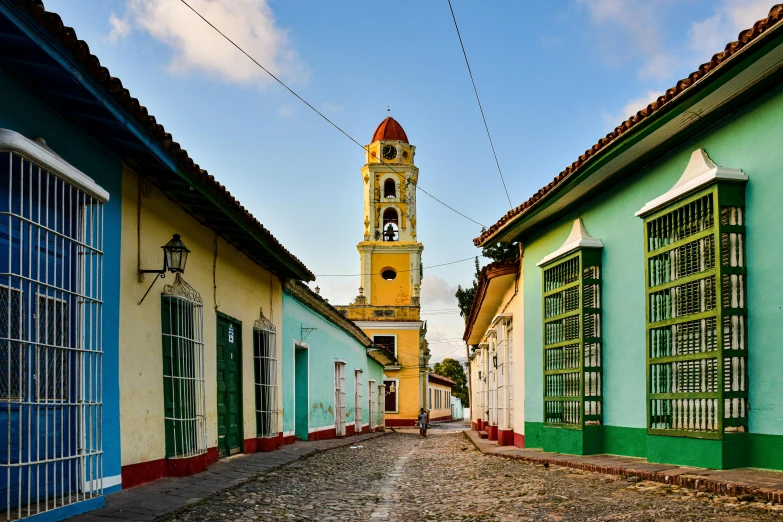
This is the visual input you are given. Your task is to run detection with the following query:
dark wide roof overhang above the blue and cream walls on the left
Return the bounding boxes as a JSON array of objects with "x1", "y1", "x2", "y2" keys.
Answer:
[{"x1": 0, "y1": 0, "x2": 315, "y2": 281}]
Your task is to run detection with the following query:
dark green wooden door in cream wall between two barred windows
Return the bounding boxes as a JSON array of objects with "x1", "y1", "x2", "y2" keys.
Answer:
[{"x1": 217, "y1": 316, "x2": 242, "y2": 457}]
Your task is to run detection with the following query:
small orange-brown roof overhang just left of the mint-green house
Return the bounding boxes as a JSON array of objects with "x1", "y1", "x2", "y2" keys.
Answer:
[{"x1": 462, "y1": 259, "x2": 519, "y2": 345}]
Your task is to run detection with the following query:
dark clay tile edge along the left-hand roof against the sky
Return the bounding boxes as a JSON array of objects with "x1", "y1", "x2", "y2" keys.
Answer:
[{"x1": 16, "y1": 0, "x2": 315, "y2": 280}]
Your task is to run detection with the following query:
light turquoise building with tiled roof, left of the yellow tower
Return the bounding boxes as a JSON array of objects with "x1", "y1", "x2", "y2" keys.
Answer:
[{"x1": 282, "y1": 281, "x2": 394, "y2": 443}]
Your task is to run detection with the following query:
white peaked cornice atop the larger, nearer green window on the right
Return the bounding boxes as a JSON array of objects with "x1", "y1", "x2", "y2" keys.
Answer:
[{"x1": 636, "y1": 149, "x2": 748, "y2": 217}]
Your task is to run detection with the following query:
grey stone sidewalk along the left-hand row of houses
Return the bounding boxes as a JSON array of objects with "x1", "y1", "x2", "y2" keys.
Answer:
[{"x1": 68, "y1": 433, "x2": 386, "y2": 522}]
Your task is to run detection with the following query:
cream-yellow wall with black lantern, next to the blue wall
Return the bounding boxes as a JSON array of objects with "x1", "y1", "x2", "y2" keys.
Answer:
[{"x1": 119, "y1": 168, "x2": 283, "y2": 466}]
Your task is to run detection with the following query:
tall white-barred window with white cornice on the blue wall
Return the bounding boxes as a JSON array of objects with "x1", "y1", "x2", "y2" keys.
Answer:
[{"x1": 0, "y1": 135, "x2": 109, "y2": 520}]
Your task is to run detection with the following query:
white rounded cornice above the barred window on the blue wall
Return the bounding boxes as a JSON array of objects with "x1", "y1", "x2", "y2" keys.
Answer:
[{"x1": 0, "y1": 129, "x2": 109, "y2": 203}]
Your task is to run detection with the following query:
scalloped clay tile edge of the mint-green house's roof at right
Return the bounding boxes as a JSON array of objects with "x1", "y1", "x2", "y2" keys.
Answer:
[{"x1": 473, "y1": 4, "x2": 783, "y2": 246}]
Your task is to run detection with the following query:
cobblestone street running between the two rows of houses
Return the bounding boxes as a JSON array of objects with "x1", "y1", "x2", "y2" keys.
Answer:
[{"x1": 159, "y1": 427, "x2": 783, "y2": 521}]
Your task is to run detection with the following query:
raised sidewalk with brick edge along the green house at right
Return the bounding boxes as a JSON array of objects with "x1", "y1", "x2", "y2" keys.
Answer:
[{"x1": 463, "y1": 430, "x2": 783, "y2": 504}]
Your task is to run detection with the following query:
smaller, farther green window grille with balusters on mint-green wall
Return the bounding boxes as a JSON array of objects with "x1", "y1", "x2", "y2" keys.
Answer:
[{"x1": 540, "y1": 238, "x2": 603, "y2": 429}]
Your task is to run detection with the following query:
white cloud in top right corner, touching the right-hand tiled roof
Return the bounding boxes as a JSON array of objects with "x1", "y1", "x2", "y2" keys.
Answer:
[{"x1": 688, "y1": 0, "x2": 772, "y2": 63}]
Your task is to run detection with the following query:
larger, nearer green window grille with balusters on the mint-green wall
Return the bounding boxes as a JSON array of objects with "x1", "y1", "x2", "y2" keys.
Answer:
[{"x1": 644, "y1": 183, "x2": 748, "y2": 439}]
